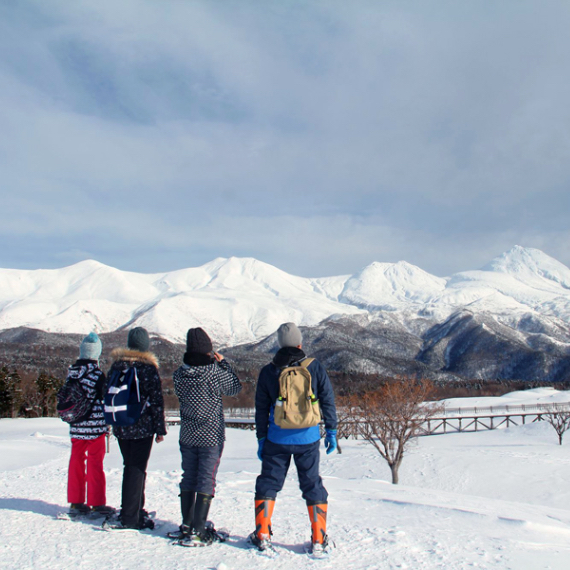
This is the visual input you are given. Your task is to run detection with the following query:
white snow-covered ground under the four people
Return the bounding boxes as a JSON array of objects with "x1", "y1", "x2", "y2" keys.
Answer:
[{"x1": 0, "y1": 390, "x2": 570, "y2": 570}]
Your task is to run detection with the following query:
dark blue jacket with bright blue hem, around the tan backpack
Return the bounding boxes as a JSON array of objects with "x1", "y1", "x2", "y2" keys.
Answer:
[{"x1": 255, "y1": 347, "x2": 337, "y2": 445}]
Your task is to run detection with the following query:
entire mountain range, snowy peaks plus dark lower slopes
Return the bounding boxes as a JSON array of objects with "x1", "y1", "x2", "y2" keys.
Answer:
[{"x1": 0, "y1": 246, "x2": 570, "y2": 382}]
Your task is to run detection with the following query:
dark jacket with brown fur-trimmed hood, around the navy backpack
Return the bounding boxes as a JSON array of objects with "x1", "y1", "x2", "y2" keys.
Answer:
[{"x1": 107, "y1": 348, "x2": 166, "y2": 439}]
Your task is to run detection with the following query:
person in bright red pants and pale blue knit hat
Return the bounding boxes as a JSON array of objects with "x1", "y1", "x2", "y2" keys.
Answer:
[{"x1": 67, "y1": 333, "x2": 114, "y2": 516}]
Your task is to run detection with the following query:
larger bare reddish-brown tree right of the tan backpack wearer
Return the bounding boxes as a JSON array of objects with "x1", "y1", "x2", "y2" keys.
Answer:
[{"x1": 351, "y1": 377, "x2": 443, "y2": 485}]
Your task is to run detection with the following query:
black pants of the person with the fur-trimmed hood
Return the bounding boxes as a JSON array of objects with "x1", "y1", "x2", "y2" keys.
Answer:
[{"x1": 119, "y1": 436, "x2": 153, "y2": 528}]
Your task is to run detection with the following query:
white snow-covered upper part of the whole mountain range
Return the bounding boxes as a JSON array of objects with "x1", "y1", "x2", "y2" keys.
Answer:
[{"x1": 0, "y1": 246, "x2": 570, "y2": 346}]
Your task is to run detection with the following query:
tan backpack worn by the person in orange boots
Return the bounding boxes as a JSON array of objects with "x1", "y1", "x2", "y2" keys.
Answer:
[{"x1": 274, "y1": 358, "x2": 321, "y2": 429}]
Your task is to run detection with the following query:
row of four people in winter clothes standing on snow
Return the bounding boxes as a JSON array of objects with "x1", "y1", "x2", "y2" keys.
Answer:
[{"x1": 62, "y1": 323, "x2": 337, "y2": 554}]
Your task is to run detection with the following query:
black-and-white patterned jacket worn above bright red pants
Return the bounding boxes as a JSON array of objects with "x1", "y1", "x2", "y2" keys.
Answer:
[{"x1": 67, "y1": 360, "x2": 107, "y2": 439}]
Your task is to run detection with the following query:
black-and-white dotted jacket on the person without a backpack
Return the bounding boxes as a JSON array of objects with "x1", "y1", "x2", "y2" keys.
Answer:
[{"x1": 172, "y1": 358, "x2": 241, "y2": 447}]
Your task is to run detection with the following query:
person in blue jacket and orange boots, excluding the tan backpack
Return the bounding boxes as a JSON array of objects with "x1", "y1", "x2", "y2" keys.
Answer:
[{"x1": 249, "y1": 323, "x2": 337, "y2": 555}]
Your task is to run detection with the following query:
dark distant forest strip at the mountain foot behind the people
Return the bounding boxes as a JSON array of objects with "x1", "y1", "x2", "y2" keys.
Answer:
[{"x1": 0, "y1": 329, "x2": 570, "y2": 417}]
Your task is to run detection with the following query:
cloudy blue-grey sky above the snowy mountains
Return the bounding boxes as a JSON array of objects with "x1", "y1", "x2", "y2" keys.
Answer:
[{"x1": 0, "y1": 0, "x2": 570, "y2": 277}]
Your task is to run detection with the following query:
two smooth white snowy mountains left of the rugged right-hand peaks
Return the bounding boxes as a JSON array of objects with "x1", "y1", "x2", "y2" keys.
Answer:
[{"x1": 0, "y1": 258, "x2": 361, "y2": 345}]
